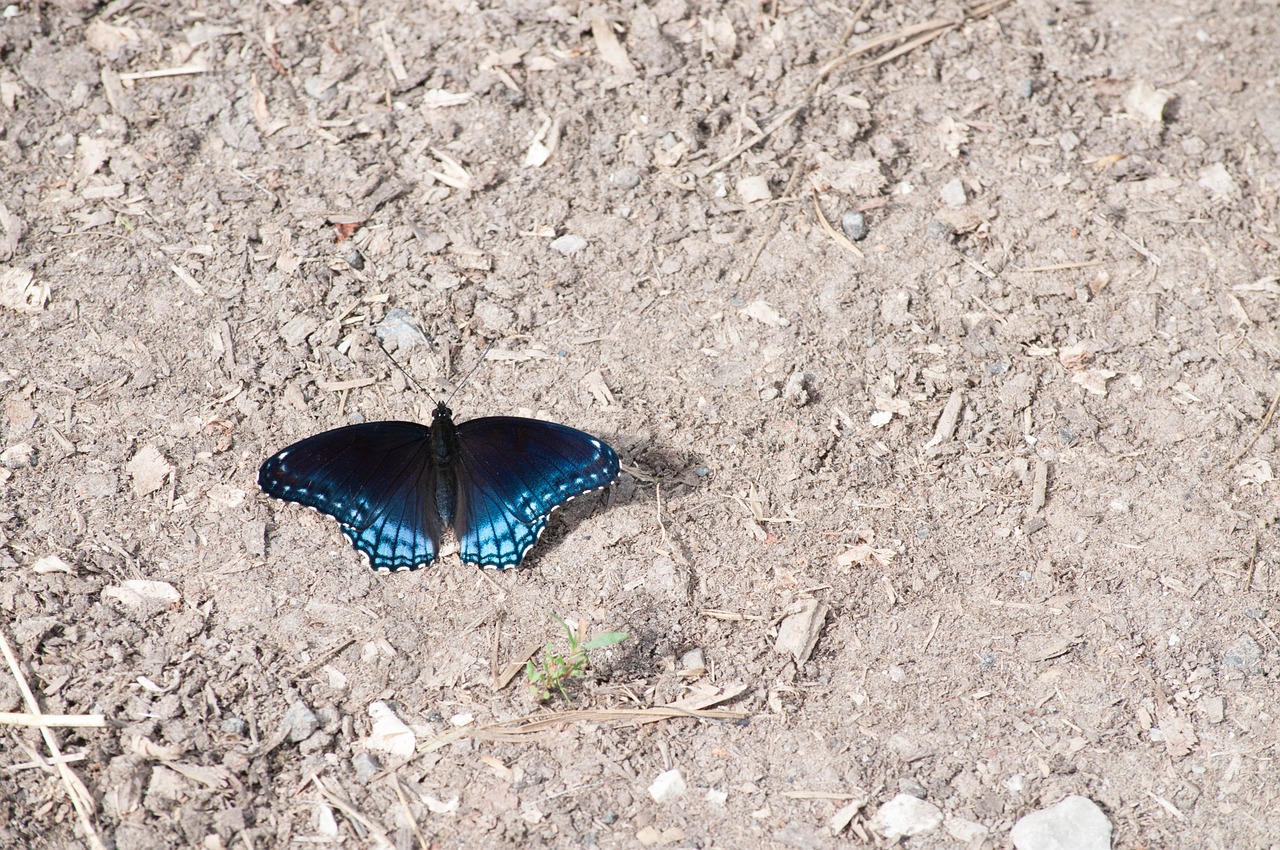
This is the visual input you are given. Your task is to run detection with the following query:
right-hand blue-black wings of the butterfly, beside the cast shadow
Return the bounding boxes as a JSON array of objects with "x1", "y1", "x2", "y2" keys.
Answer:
[{"x1": 453, "y1": 416, "x2": 618, "y2": 568}]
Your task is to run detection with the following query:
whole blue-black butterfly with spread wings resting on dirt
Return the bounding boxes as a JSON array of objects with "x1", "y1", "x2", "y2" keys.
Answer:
[{"x1": 257, "y1": 402, "x2": 618, "y2": 572}]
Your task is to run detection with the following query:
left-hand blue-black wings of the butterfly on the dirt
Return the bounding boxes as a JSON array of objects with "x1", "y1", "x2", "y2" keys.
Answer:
[{"x1": 257, "y1": 422, "x2": 442, "y2": 571}]
